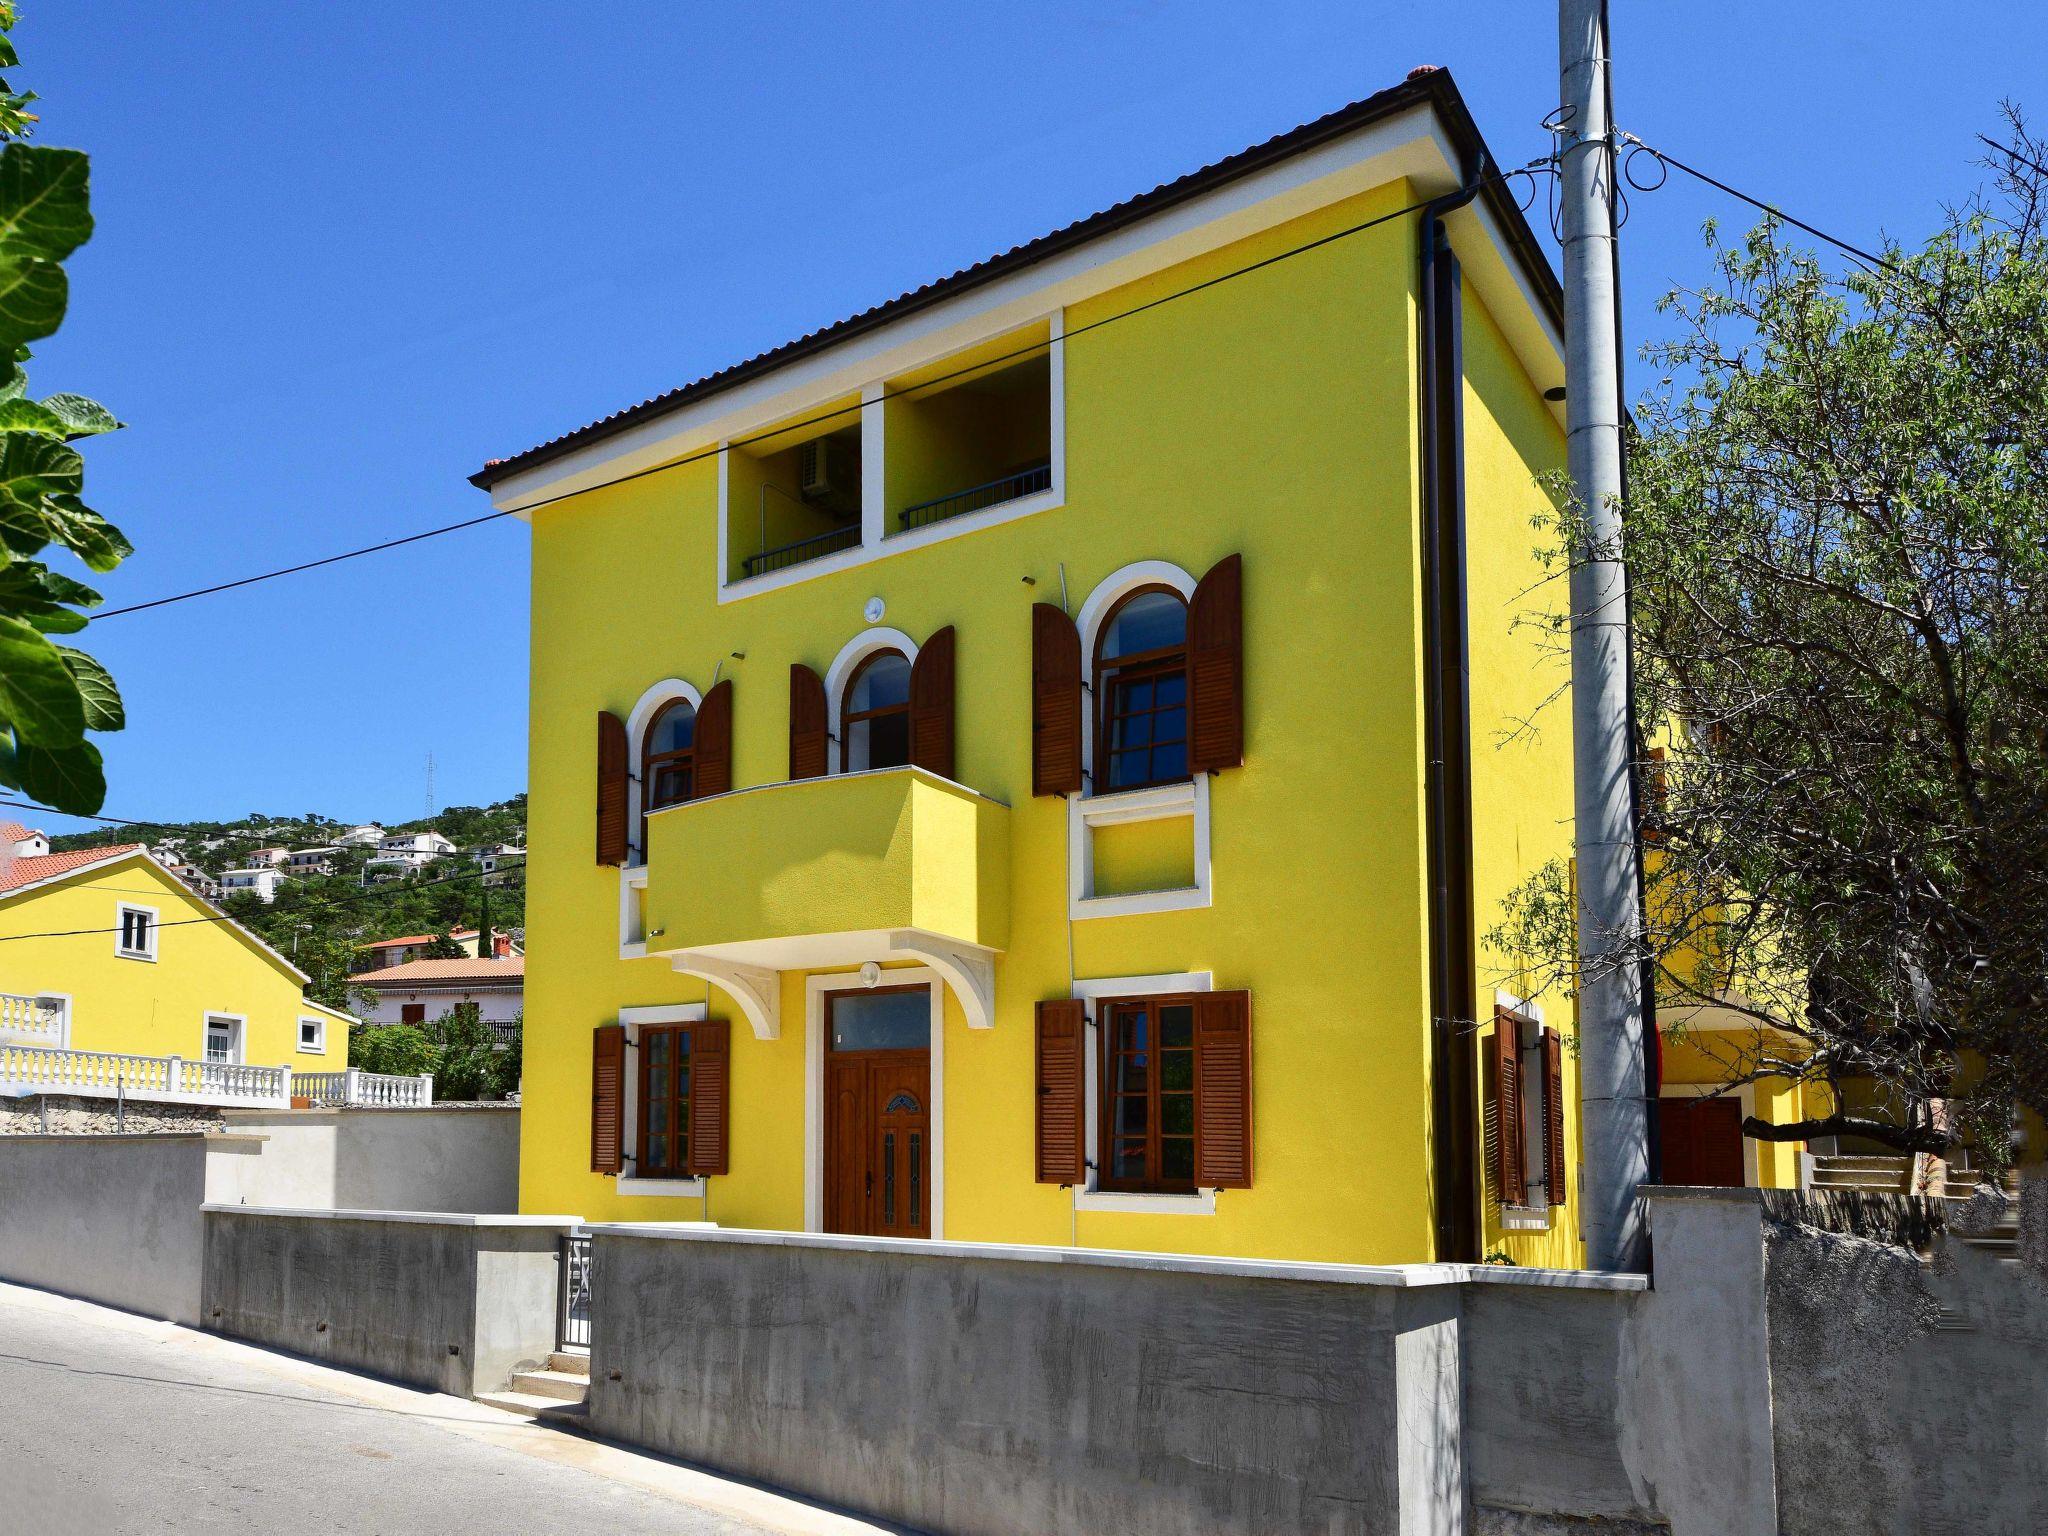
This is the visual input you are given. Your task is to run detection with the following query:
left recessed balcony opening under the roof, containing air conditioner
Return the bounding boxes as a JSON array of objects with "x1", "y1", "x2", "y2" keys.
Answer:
[{"x1": 725, "y1": 410, "x2": 860, "y2": 582}]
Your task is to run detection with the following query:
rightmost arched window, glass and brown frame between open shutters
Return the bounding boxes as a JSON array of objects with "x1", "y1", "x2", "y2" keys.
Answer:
[{"x1": 1094, "y1": 586, "x2": 1188, "y2": 793}]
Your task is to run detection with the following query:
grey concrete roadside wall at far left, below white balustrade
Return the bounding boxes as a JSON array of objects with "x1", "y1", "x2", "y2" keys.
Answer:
[{"x1": 0, "y1": 1133, "x2": 262, "y2": 1323}]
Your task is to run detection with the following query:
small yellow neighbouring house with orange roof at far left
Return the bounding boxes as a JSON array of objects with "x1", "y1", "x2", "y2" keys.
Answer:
[{"x1": 0, "y1": 821, "x2": 350, "y2": 1098}]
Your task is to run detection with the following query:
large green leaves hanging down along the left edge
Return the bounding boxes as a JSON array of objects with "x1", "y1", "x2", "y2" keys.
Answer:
[{"x1": 0, "y1": 0, "x2": 131, "y2": 813}]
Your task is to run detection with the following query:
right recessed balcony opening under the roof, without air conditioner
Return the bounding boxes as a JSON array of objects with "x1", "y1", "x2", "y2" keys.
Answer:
[{"x1": 885, "y1": 334, "x2": 1053, "y2": 535}]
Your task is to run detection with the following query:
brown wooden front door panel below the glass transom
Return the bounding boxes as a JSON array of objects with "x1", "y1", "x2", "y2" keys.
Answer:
[{"x1": 825, "y1": 1051, "x2": 932, "y2": 1237}]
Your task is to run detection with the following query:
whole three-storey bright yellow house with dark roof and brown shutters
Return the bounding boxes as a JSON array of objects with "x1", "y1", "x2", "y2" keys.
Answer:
[{"x1": 487, "y1": 72, "x2": 1581, "y2": 1264}]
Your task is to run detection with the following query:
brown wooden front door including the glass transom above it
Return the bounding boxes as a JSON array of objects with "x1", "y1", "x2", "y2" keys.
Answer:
[{"x1": 823, "y1": 987, "x2": 932, "y2": 1237}]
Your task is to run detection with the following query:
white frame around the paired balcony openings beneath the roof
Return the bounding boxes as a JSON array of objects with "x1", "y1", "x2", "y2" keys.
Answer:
[{"x1": 719, "y1": 309, "x2": 1067, "y2": 604}]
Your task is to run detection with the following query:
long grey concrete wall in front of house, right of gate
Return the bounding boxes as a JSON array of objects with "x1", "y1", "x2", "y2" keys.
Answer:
[{"x1": 590, "y1": 1225, "x2": 1638, "y2": 1536}]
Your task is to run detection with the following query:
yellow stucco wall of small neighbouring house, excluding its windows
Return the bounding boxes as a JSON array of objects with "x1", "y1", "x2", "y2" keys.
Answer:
[{"x1": 0, "y1": 850, "x2": 350, "y2": 1071}]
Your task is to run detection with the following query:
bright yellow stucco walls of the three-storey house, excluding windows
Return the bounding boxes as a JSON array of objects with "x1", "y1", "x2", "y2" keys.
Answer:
[{"x1": 487, "y1": 81, "x2": 1581, "y2": 1266}]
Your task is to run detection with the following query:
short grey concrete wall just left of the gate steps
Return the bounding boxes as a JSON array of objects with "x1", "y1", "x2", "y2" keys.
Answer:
[{"x1": 201, "y1": 1206, "x2": 575, "y2": 1397}]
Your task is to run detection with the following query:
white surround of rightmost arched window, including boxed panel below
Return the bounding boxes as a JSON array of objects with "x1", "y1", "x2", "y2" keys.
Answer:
[{"x1": 1067, "y1": 559, "x2": 1214, "y2": 922}]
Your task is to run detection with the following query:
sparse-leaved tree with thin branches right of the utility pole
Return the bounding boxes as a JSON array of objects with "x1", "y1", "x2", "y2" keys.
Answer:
[{"x1": 1495, "y1": 115, "x2": 2048, "y2": 1163}]
